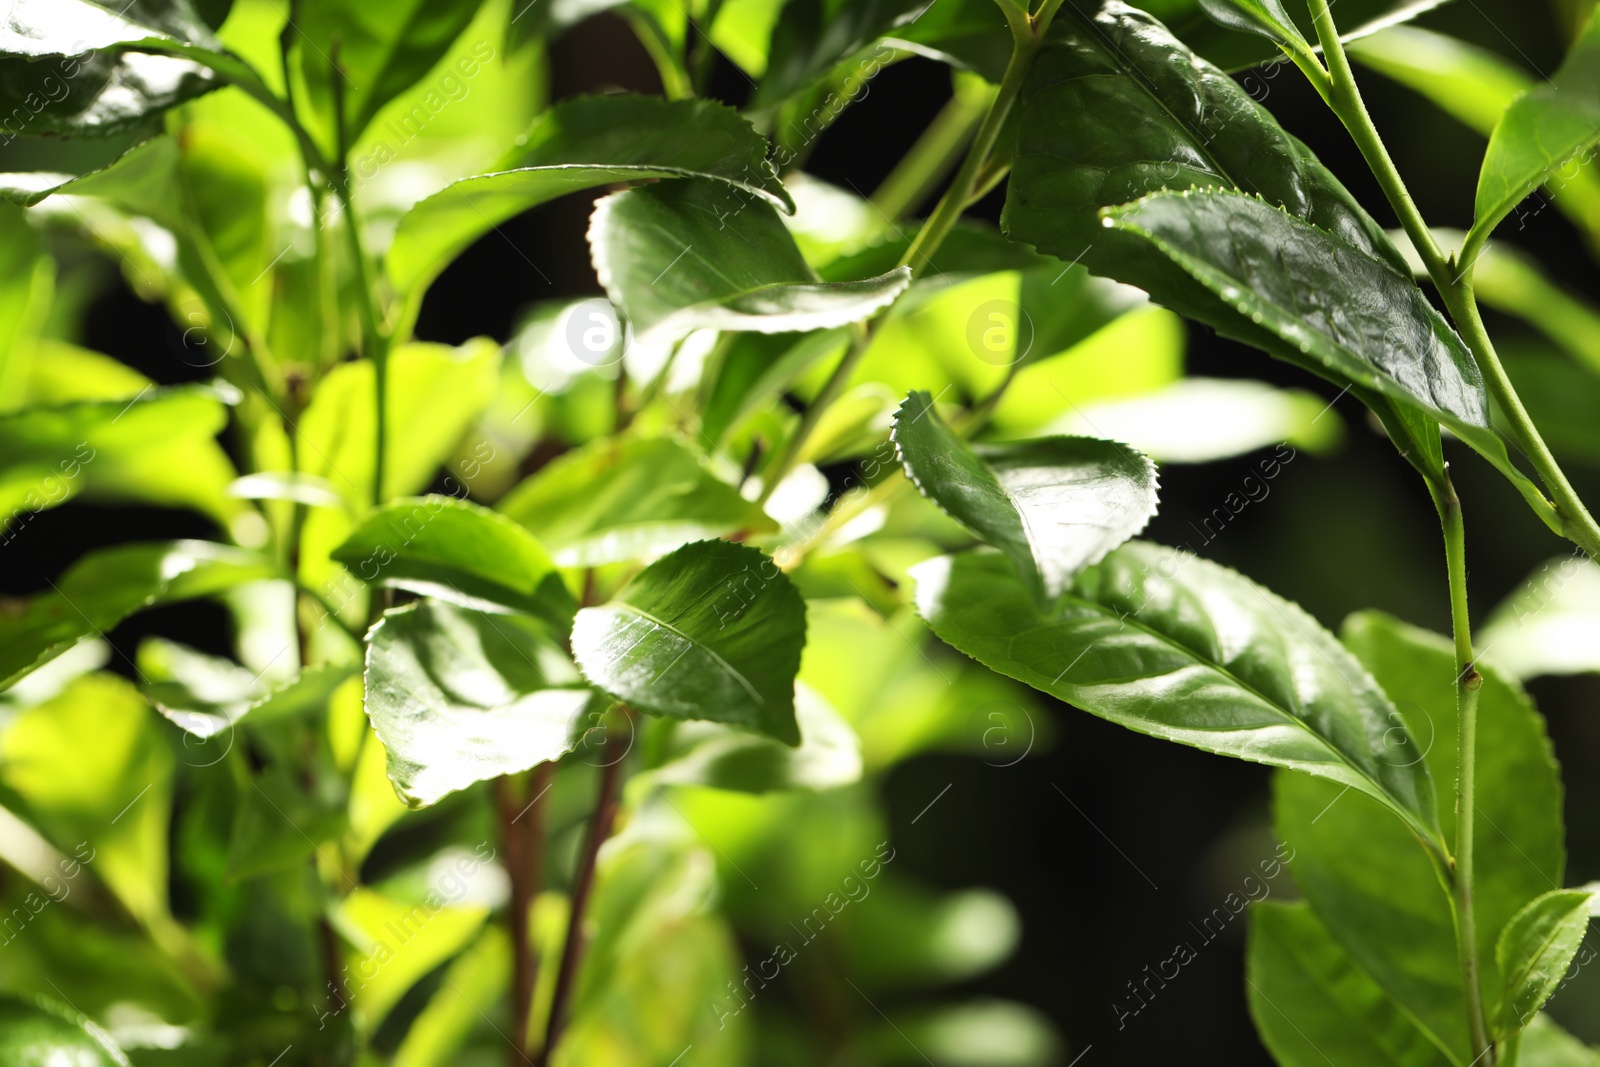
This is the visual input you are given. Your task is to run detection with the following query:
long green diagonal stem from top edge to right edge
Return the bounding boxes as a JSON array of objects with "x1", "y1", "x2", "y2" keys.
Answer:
[{"x1": 1312, "y1": 0, "x2": 1600, "y2": 555}]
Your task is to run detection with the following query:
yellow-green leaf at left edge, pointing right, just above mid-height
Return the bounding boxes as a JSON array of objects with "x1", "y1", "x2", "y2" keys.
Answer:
[{"x1": 0, "y1": 386, "x2": 242, "y2": 531}]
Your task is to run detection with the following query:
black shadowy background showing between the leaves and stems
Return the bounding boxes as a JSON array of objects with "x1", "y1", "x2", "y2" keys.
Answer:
[{"x1": 12, "y1": 0, "x2": 1600, "y2": 1065}]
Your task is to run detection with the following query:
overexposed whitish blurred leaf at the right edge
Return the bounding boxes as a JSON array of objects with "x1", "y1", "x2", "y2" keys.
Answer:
[{"x1": 1477, "y1": 555, "x2": 1600, "y2": 678}]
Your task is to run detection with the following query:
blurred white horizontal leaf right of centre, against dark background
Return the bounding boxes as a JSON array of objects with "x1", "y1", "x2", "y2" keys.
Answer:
[{"x1": 1050, "y1": 378, "x2": 1344, "y2": 462}]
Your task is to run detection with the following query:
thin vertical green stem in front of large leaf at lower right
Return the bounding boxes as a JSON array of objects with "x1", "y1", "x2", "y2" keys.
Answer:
[{"x1": 1429, "y1": 470, "x2": 1494, "y2": 1064}]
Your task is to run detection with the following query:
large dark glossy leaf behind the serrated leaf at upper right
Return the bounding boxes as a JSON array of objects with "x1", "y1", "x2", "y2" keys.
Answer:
[{"x1": 1000, "y1": 0, "x2": 1459, "y2": 493}]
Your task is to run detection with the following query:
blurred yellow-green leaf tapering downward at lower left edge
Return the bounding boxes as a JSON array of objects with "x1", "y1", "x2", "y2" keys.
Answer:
[{"x1": 0, "y1": 673, "x2": 173, "y2": 925}]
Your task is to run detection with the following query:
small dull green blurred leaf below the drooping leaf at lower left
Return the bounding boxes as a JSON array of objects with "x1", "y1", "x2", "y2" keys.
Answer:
[{"x1": 227, "y1": 765, "x2": 344, "y2": 881}]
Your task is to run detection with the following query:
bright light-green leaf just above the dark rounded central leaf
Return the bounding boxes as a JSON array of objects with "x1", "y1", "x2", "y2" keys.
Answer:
[{"x1": 499, "y1": 437, "x2": 776, "y2": 566}]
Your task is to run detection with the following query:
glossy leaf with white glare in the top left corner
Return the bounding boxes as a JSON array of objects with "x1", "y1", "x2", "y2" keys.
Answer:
[{"x1": 0, "y1": 0, "x2": 221, "y2": 138}]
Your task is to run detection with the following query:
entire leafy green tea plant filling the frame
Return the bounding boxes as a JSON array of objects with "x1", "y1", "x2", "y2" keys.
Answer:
[{"x1": 0, "y1": 0, "x2": 1600, "y2": 1067}]
